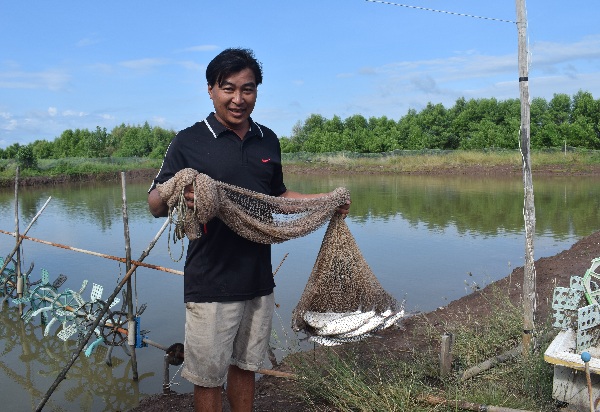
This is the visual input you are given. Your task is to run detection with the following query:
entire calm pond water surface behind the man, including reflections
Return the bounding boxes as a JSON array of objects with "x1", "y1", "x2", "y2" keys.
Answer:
[{"x1": 0, "y1": 175, "x2": 600, "y2": 412}]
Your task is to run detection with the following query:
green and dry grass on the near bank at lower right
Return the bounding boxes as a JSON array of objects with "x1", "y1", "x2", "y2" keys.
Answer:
[{"x1": 290, "y1": 286, "x2": 556, "y2": 412}]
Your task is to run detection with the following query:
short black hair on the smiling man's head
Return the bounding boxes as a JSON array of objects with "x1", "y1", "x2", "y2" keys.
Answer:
[{"x1": 206, "y1": 48, "x2": 262, "y2": 86}]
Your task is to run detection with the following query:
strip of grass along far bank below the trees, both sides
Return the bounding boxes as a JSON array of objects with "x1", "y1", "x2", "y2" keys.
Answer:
[{"x1": 0, "y1": 150, "x2": 600, "y2": 180}]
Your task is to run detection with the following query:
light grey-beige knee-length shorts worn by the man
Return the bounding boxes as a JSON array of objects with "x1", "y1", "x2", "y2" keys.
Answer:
[{"x1": 181, "y1": 293, "x2": 275, "y2": 387}]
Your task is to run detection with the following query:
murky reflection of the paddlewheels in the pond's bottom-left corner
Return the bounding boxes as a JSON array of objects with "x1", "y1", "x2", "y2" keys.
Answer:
[{"x1": 0, "y1": 302, "x2": 154, "y2": 411}]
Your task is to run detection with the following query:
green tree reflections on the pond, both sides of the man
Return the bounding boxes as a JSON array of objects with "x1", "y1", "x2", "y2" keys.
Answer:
[{"x1": 0, "y1": 175, "x2": 600, "y2": 237}]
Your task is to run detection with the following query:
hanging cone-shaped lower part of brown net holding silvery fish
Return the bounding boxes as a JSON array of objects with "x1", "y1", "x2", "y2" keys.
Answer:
[{"x1": 292, "y1": 214, "x2": 404, "y2": 346}]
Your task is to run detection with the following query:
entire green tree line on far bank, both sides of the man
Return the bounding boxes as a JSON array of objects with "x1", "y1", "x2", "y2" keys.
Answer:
[{"x1": 0, "y1": 90, "x2": 600, "y2": 167}]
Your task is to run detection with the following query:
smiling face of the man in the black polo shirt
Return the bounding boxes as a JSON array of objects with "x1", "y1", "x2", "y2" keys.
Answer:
[{"x1": 208, "y1": 69, "x2": 257, "y2": 130}]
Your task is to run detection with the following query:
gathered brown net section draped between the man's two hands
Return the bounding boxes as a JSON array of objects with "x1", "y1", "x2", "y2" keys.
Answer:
[{"x1": 156, "y1": 168, "x2": 350, "y2": 244}]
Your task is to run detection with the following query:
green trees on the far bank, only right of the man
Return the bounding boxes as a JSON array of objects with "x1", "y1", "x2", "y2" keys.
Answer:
[{"x1": 281, "y1": 91, "x2": 600, "y2": 153}]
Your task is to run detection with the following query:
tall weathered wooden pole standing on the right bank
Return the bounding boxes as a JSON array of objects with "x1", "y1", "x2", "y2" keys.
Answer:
[{"x1": 516, "y1": 0, "x2": 536, "y2": 354}]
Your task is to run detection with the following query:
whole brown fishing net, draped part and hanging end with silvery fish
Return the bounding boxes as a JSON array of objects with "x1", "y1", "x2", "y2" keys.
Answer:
[{"x1": 156, "y1": 169, "x2": 404, "y2": 345}]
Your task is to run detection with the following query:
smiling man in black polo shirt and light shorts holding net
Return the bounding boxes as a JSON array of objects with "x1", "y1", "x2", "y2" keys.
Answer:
[{"x1": 148, "y1": 49, "x2": 350, "y2": 412}]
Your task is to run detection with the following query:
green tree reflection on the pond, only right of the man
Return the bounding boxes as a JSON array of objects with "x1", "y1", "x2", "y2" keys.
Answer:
[{"x1": 287, "y1": 175, "x2": 600, "y2": 238}]
